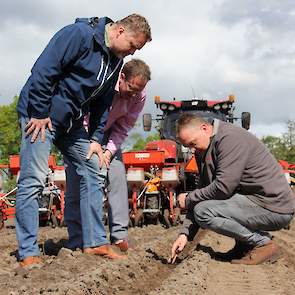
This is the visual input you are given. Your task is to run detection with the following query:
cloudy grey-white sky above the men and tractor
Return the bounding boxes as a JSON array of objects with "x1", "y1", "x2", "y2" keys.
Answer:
[{"x1": 0, "y1": 0, "x2": 295, "y2": 136}]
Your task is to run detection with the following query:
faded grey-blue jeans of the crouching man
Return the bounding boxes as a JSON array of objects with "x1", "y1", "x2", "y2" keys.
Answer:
[{"x1": 194, "y1": 194, "x2": 293, "y2": 246}]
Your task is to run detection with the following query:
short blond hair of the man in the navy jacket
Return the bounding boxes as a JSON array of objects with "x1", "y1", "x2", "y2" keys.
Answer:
[{"x1": 116, "y1": 13, "x2": 152, "y2": 42}]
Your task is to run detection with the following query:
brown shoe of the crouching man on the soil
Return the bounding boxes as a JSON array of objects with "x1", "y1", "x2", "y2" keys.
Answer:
[{"x1": 231, "y1": 241, "x2": 280, "y2": 265}]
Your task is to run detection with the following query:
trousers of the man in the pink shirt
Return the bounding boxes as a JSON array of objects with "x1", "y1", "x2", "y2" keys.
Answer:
[{"x1": 64, "y1": 151, "x2": 129, "y2": 249}]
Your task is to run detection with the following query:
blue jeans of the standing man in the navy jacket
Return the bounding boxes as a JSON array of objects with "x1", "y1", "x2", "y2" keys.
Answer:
[{"x1": 16, "y1": 118, "x2": 108, "y2": 259}]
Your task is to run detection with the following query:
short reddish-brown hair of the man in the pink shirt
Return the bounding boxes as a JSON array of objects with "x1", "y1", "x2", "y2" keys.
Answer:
[{"x1": 122, "y1": 58, "x2": 151, "y2": 82}]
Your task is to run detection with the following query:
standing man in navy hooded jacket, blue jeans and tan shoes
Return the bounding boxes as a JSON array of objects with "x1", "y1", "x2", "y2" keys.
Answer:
[{"x1": 16, "y1": 14, "x2": 151, "y2": 267}]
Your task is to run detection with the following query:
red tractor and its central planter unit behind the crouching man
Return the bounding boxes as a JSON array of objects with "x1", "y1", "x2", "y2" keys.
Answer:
[{"x1": 123, "y1": 95, "x2": 250, "y2": 227}]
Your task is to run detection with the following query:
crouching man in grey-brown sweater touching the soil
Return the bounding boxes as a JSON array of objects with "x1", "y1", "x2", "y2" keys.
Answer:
[{"x1": 171, "y1": 114, "x2": 295, "y2": 265}]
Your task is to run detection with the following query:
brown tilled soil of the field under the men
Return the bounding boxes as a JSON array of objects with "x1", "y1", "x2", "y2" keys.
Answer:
[{"x1": 0, "y1": 219, "x2": 295, "y2": 295}]
